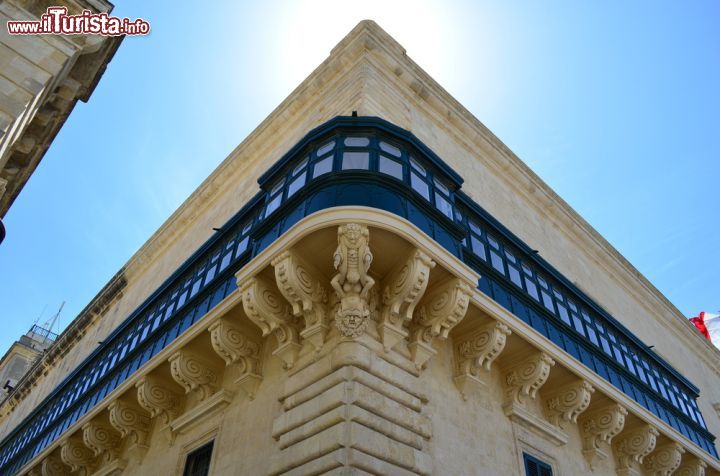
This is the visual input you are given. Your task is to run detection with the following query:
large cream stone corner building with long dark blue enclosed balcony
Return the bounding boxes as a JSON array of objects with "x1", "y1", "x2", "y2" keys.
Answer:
[{"x1": 0, "y1": 21, "x2": 720, "y2": 476}]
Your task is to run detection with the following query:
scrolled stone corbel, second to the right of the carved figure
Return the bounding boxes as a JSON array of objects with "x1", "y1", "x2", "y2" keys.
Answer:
[{"x1": 408, "y1": 278, "x2": 472, "y2": 370}]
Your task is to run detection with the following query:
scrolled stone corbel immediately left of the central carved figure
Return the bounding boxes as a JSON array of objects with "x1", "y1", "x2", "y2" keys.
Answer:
[{"x1": 271, "y1": 250, "x2": 330, "y2": 350}]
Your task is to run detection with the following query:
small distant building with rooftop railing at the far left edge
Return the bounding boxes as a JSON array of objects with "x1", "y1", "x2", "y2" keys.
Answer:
[{"x1": 0, "y1": 325, "x2": 57, "y2": 403}]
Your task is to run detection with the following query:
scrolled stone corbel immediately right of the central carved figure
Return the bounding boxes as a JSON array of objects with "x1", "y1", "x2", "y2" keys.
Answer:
[{"x1": 378, "y1": 249, "x2": 435, "y2": 351}]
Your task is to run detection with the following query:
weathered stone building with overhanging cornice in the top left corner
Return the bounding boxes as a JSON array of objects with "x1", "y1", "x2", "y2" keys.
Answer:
[{"x1": 0, "y1": 0, "x2": 122, "y2": 242}]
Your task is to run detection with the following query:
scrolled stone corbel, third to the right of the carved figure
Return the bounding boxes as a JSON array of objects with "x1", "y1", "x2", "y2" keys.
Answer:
[{"x1": 453, "y1": 322, "x2": 510, "y2": 400}]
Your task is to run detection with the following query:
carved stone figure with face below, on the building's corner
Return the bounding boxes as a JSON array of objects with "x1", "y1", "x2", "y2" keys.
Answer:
[{"x1": 330, "y1": 223, "x2": 375, "y2": 338}]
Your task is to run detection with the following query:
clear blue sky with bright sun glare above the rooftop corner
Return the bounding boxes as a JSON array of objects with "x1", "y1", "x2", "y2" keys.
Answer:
[{"x1": 0, "y1": 0, "x2": 720, "y2": 352}]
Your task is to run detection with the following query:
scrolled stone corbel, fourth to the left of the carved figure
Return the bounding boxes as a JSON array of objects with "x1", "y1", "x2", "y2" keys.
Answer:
[{"x1": 168, "y1": 350, "x2": 220, "y2": 402}]
